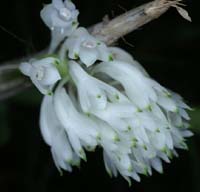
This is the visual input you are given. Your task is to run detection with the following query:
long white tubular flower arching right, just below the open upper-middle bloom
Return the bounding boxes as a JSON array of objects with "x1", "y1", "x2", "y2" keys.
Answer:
[{"x1": 95, "y1": 60, "x2": 157, "y2": 109}]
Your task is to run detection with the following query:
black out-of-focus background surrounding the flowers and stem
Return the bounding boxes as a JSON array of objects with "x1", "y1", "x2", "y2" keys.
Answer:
[{"x1": 0, "y1": 0, "x2": 200, "y2": 192}]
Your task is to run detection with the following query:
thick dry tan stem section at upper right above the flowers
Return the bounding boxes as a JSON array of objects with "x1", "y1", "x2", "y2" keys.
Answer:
[{"x1": 89, "y1": 0, "x2": 171, "y2": 45}]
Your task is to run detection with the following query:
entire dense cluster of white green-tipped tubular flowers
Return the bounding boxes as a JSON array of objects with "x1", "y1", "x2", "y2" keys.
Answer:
[{"x1": 20, "y1": 0, "x2": 192, "y2": 185}]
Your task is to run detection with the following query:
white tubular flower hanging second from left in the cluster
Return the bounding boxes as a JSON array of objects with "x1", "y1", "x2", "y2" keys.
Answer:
[{"x1": 54, "y1": 82, "x2": 99, "y2": 159}]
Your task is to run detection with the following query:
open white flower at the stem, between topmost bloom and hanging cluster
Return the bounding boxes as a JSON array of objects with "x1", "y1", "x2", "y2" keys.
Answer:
[{"x1": 61, "y1": 27, "x2": 113, "y2": 66}]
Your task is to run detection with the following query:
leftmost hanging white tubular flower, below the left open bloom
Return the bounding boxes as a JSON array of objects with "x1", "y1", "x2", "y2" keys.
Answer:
[{"x1": 40, "y1": 96, "x2": 80, "y2": 171}]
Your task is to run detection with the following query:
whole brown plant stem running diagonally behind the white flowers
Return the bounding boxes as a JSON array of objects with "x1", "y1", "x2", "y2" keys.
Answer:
[{"x1": 0, "y1": 0, "x2": 188, "y2": 100}]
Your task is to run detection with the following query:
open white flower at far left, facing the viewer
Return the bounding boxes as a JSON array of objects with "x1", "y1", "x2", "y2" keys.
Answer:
[{"x1": 19, "y1": 57, "x2": 61, "y2": 95}]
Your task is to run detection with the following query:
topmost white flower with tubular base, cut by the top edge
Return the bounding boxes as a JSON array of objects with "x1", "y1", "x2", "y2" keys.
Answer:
[{"x1": 40, "y1": 0, "x2": 79, "y2": 52}]
